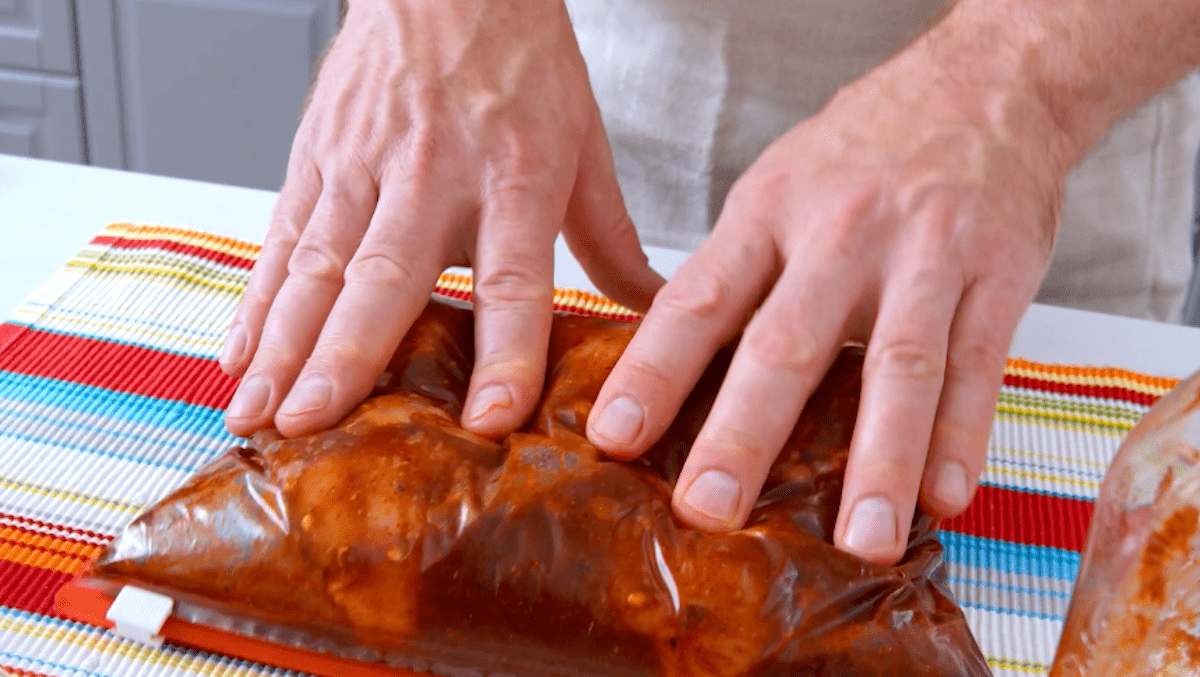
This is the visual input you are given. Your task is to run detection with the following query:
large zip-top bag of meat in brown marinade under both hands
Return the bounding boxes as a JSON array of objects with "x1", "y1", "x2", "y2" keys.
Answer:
[{"x1": 61, "y1": 302, "x2": 990, "y2": 677}]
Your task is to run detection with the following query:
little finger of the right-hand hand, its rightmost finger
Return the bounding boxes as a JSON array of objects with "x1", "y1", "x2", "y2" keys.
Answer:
[{"x1": 920, "y1": 283, "x2": 1032, "y2": 517}]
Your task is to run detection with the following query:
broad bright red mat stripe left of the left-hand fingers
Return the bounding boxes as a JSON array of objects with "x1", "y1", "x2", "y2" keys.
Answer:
[{"x1": 0, "y1": 330, "x2": 238, "y2": 409}]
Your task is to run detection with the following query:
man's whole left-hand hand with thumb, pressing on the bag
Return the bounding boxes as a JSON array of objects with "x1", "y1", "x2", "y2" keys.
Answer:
[{"x1": 221, "y1": 0, "x2": 661, "y2": 436}]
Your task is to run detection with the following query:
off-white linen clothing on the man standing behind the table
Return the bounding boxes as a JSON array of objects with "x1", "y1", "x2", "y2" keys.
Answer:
[{"x1": 566, "y1": 0, "x2": 1200, "y2": 320}]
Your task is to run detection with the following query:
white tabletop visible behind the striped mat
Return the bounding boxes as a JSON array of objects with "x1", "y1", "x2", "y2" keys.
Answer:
[{"x1": 7, "y1": 155, "x2": 1200, "y2": 377}]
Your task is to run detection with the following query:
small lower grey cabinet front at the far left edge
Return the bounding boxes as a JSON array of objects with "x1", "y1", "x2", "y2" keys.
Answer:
[{"x1": 0, "y1": 71, "x2": 84, "y2": 162}]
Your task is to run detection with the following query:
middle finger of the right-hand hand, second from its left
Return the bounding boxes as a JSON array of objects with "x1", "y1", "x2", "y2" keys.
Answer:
[{"x1": 672, "y1": 257, "x2": 859, "y2": 531}]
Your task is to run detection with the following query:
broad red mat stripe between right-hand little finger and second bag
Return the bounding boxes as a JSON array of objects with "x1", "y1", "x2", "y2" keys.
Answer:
[{"x1": 942, "y1": 485, "x2": 1092, "y2": 552}]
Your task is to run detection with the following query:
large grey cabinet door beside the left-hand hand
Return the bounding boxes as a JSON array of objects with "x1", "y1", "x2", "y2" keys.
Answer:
[{"x1": 81, "y1": 0, "x2": 338, "y2": 190}]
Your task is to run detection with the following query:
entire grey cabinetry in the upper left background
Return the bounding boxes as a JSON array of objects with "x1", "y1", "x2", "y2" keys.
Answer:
[{"x1": 0, "y1": 0, "x2": 340, "y2": 188}]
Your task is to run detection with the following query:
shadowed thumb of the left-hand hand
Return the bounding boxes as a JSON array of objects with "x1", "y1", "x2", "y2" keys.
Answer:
[{"x1": 563, "y1": 113, "x2": 664, "y2": 312}]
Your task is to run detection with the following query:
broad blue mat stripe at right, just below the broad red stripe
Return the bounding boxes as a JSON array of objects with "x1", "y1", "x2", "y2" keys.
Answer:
[{"x1": 938, "y1": 532, "x2": 1079, "y2": 583}]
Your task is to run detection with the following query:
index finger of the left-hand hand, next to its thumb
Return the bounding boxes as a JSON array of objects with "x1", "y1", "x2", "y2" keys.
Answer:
[{"x1": 462, "y1": 180, "x2": 568, "y2": 437}]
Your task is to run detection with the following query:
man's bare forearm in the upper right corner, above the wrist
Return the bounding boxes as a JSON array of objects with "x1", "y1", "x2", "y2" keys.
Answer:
[{"x1": 912, "y1": 0, "x2": 1200, "y2": 166}]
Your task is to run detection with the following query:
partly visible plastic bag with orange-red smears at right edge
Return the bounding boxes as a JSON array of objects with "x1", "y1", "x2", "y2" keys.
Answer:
[{"x1": 1050, "y1": 367, "x2": 1200, "y2": 677}]
